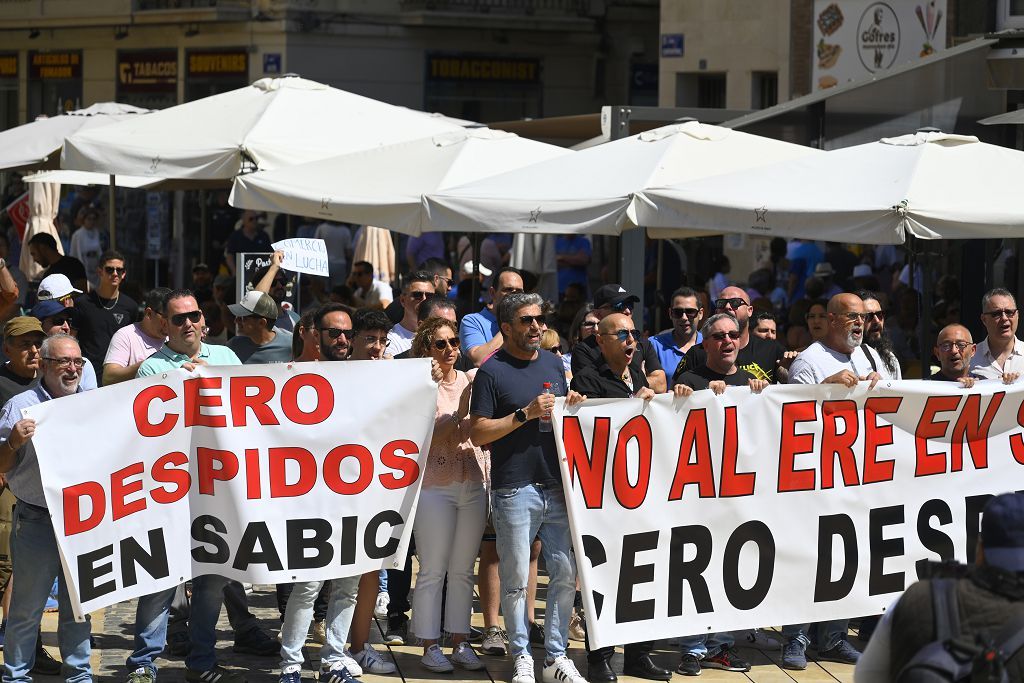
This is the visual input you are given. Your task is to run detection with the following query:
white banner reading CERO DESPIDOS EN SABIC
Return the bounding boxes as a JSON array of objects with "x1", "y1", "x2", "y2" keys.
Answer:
[{"x1": 27, "y1": 359, "x2": 437, "y2": 616}]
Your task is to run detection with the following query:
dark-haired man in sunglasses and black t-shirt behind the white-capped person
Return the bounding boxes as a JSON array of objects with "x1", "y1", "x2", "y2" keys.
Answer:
[{"x1": 75, "y1": 251, "x2": 138, "y2": 385}]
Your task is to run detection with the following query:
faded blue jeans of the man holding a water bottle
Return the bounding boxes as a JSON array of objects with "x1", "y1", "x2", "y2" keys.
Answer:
[{"x1": 490, "y1": 484, "x2": 575, "y2": 659}]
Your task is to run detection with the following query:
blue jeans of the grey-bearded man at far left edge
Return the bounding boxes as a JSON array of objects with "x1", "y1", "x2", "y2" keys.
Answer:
[{"x1": 3, "y1": 501, "x2": 92, "y2": 683}]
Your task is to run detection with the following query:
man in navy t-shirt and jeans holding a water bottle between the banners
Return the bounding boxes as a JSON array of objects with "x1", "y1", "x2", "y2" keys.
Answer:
[{"x1": 470, "y1": 292, "x2": 586, "y2": 683}]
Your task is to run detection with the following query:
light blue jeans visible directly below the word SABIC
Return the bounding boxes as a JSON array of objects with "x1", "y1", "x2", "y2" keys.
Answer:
[{"x1": 281, "y1": 575, "x2": 359, "y2": 672}]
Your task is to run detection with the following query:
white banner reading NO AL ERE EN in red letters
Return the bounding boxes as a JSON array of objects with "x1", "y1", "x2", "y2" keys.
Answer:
[{"x1": 554, "y1": 381, "x2": 1024, "y2": 647}]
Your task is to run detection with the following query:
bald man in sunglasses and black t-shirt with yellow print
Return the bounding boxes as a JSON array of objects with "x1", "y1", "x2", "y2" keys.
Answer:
[{"x1": 672, "y1": 287, "x2": 796, "y2": 384}]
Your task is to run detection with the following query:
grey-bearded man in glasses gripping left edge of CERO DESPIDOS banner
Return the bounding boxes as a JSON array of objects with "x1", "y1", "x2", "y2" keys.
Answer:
[{"x1": 0, "y1": 334, "x2": 92, "y2": 683}]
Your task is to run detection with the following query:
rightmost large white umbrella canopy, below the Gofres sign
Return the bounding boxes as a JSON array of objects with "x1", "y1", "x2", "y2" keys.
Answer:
[{"x1": 636, "y1": 133, "x2": 1024, "y2": 244}]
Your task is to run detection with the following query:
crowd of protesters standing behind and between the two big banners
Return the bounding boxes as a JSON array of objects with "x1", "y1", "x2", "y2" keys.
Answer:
[{"x1": 0, "y1": 214, "x2": 1024, "y2": 683}]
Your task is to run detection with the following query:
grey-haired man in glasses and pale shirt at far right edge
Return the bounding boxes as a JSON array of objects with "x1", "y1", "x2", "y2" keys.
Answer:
[{"x1": 971, "y1": 288, "x2": 1024, "y2": 382}]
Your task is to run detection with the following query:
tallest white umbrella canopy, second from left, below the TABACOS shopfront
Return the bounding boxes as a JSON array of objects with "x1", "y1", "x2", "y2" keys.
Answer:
[{"x1": 61, "y1": 77, "x2": 461, "y2": 180}]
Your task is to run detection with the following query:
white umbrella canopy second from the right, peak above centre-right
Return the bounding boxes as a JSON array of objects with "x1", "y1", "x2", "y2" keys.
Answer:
[{"x1": 423, "y1": 121, "x2": 818, "y2": 234}]
